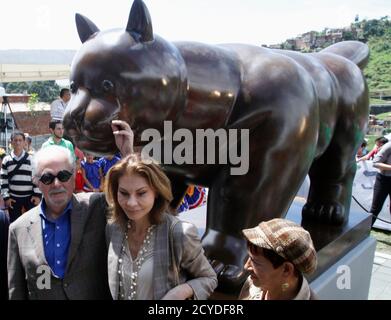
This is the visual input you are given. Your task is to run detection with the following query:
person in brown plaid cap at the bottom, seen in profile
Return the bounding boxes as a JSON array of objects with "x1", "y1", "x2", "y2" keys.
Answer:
[{"x1": 239, "y1": 219, "x2": 317, "y2": 300}]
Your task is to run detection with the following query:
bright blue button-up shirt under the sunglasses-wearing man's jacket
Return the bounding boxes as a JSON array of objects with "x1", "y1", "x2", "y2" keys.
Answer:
[{"x1": 40, "y1": 199, "x2": 72, "y2": 279}]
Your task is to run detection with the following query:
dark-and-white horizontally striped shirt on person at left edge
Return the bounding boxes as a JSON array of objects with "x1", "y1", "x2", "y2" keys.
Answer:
[{"x1": 0, "y1": 151, "x2": 41, "y2": 200}]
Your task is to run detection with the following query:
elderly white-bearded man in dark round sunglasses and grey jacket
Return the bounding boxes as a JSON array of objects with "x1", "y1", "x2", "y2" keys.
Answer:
[{"x1": 8, "y1": 120, "x2": 133, "y2": 300}]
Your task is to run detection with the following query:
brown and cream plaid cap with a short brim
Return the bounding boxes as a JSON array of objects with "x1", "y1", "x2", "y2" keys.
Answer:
[{"x1": 242, "y1": 219, "x2": 317, "y2": 274}]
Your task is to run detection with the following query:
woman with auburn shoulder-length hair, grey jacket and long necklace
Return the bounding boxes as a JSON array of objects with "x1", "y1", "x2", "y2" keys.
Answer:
[{"x1": 105, "y1": 154, "x2": 217, "y2": 300}]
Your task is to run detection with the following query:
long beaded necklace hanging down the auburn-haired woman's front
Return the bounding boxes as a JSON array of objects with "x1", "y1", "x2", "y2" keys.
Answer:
[{"x1": 118, "y1": 221, "x2": 155, "y2": 300}]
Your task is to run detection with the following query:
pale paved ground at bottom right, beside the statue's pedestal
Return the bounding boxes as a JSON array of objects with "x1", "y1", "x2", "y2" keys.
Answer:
[{"x1": 368, "y1": 230, "x2": 391, "y2": 300}]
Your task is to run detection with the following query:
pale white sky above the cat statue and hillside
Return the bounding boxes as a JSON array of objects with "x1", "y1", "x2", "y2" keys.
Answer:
[{"x1": 0, "y1": 0, "x2": 391, "y2": 50}]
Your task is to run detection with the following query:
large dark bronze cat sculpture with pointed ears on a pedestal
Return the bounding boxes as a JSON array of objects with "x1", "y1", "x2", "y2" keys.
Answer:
[{"x1": 64, "y1": 0, "x2": 369, "y2": 290}]
